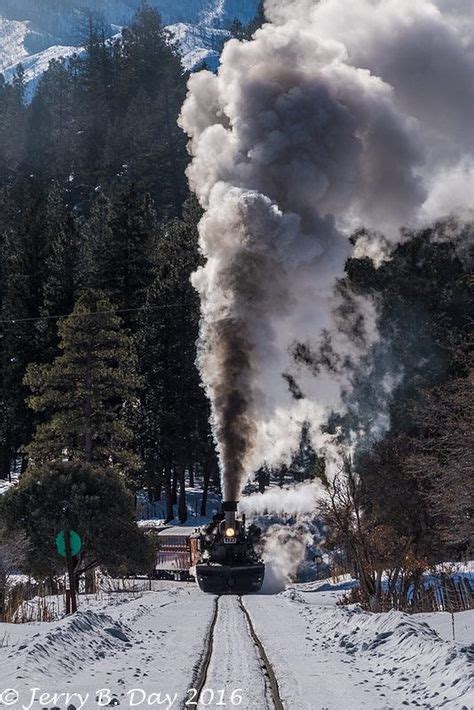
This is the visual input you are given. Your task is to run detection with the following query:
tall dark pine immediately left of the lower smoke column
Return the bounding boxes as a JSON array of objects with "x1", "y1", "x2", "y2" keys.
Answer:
[{"x1": 137, "y1": 201, "x2": 215, "y2": 519}]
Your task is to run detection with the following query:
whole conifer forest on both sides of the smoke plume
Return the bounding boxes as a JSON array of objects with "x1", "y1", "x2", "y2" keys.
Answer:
[{"x1": 0, "y1": 1, "x2": 473, "y2": 584}]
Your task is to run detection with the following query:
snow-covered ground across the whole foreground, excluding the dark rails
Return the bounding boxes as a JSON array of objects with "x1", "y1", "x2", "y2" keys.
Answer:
[{"x1": 0, "y1": 581, "x2": 474, "y2": 710}]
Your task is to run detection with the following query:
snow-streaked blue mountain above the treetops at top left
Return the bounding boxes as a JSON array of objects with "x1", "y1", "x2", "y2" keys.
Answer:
[{"x1": 0, "y1": 0, "x2": 258, "y2": 95}]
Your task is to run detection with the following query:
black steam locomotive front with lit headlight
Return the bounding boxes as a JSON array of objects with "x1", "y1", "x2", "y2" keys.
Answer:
[{"x1": 196, "y1": 502, "x2": 265, "y2": 594}]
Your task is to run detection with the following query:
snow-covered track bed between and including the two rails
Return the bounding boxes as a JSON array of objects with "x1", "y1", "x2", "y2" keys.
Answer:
[{"x1": 193, "y1": 596, "x2": 284, "y2": 710}]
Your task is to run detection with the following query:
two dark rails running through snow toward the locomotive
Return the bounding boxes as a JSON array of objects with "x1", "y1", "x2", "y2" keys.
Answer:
[{"x1": 186, "y1": 596, "x2": 285, "y2": 710}]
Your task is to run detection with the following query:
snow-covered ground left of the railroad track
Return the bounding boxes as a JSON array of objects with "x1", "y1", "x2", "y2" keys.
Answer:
[{"x1": 0, "y1": 583, "x2": 214, "y2": 710}]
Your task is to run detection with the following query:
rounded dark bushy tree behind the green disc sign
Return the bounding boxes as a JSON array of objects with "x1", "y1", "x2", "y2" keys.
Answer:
[{"x1": 0, "y1": 461, "x2": 156, "y2": 579}]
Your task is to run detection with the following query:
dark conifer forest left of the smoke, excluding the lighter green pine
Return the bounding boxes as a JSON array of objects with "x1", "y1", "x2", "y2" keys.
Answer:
[{"x1": 0, "y1": 8, "x2": 215, "y2": 524}]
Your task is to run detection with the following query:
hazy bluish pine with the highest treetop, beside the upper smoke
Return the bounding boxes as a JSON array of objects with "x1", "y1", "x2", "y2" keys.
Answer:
[{"x1": 117, "y1": 4, "x2": 188, "y2": 217}]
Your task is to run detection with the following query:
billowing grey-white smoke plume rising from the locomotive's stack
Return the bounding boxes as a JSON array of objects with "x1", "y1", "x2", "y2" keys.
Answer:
[{"x1": 180, "y1": 0, "x2": 474, "y2": 499}]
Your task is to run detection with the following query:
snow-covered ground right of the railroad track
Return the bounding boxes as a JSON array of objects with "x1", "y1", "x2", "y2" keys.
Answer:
[{"x1": 245, "y1": 579, "x2": 474, "y2": 710}]
